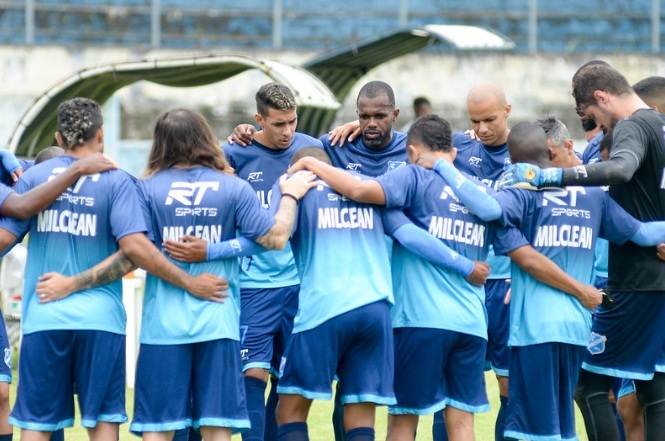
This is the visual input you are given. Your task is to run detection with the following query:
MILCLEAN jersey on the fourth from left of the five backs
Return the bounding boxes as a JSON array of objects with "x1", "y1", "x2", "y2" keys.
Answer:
[{"x1": 377, "y1": 165, "x2": 492, "y2": 339}]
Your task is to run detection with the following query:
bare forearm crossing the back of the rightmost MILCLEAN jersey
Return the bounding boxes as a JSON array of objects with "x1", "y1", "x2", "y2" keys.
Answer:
[{"x1": 507, "y1": 245, "x2": 602, "y2": 310}]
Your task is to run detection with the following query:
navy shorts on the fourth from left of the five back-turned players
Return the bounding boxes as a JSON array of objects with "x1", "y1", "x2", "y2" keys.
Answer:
[{"x1": 388, "y1": 328, "x2": 490, "y2": 415}]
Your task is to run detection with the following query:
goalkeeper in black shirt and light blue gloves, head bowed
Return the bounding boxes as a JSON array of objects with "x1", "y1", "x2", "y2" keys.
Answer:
[{"x1": 500, "y1": 65, "x2": 665, "y2": 441}]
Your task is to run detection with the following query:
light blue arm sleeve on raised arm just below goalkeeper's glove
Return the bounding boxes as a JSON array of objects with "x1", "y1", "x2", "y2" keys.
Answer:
[{"x1": 434, "y1": 159, "x2": 502, "y2": 222}]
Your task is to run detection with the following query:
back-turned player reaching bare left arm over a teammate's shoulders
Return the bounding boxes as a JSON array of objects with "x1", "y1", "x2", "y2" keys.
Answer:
[{"x1": 292, "y1": 115, "x2": 504, "y2": 440}]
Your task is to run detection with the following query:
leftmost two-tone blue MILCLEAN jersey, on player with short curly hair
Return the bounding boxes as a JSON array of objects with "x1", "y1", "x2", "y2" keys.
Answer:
[{"x1": 0, "y1": 156, "x2": 146, "y2": 334}]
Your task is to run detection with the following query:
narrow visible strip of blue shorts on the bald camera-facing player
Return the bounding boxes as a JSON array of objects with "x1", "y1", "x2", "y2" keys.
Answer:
[{"x1": 485, "y1": 279, "x2": 510, "y2": 377}]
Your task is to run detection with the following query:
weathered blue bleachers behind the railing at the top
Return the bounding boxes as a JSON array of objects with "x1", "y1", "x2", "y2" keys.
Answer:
[{"x1": 0, "y1": 0, "x2": 665, "y2": 53}]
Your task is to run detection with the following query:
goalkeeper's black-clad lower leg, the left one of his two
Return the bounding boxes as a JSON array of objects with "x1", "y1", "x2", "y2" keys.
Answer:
[{"x1": 575, "y1": 369, "x2": 619, "y2": 441}]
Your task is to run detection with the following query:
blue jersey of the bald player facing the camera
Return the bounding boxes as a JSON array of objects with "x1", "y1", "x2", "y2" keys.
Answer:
[{"x1": 453, "y1": 133, "x2": 510, "y2": 279}]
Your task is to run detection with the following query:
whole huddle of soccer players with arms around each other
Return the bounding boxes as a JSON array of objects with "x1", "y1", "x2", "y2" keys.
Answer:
[{"x1": 0, "y1": 61, "x2": 665, "y2": 441}]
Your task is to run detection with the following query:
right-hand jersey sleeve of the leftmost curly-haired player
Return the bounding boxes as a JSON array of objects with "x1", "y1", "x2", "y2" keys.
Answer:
[{"x1": 109, "y1": 170, "x2": 147, "y2": 241}]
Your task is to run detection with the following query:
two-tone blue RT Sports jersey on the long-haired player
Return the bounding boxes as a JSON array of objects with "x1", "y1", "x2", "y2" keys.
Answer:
[{"x1": 139, "y1": 167, "x2": 274, "y2": 345}]
